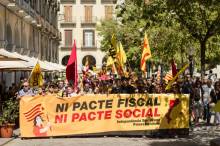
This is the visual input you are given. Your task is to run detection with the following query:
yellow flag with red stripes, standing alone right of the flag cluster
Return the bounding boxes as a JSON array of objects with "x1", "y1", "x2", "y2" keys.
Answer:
[{"x1": 141, "y1": 32, "x2": 151, "y2": 72}]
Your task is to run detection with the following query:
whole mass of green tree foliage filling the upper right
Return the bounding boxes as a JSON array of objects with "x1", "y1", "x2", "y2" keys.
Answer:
[{"x1": 97, "y1": 0, "x2": 220, "y2": 72}]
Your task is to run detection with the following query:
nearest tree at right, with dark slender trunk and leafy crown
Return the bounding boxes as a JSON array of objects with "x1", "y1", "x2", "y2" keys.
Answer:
[{"x1": 166, "y1": 0, "x2": 220, "y2": 75}]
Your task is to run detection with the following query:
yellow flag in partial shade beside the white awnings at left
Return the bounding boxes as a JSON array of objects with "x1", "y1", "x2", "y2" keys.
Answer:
[{"x1": 29, "y1": 61, "x2": 44, "y2": 87}]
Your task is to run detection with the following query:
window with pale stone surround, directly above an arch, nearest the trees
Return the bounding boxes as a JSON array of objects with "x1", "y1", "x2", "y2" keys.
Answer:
[{"x1": 83, "y1": 30, "x2": 95, "y2": 47}]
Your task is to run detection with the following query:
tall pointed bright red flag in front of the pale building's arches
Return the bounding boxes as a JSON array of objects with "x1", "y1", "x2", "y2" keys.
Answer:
[{"x1": 66, "y1": 40, "x2": 78, "y2": 89}]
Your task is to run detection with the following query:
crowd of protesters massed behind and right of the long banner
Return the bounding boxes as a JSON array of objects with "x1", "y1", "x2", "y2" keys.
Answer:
[{"x1": 1, "y1": 68, "x2": 220, "y2": 128}]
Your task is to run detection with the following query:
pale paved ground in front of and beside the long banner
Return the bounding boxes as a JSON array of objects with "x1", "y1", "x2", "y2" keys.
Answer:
[{"x1": 0, "y1": 127, "x2": 220, "y2": 146}]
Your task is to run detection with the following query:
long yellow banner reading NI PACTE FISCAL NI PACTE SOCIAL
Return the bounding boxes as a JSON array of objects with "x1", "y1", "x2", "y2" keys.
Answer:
[{"x1": 20, "y1": 94, "x2": 189, "y2": 137}]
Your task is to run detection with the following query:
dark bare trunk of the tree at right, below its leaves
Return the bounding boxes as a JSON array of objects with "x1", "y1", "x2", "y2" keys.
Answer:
[{"x1": 200, "y1": 40, "x2": 206, "y2": 78}]
